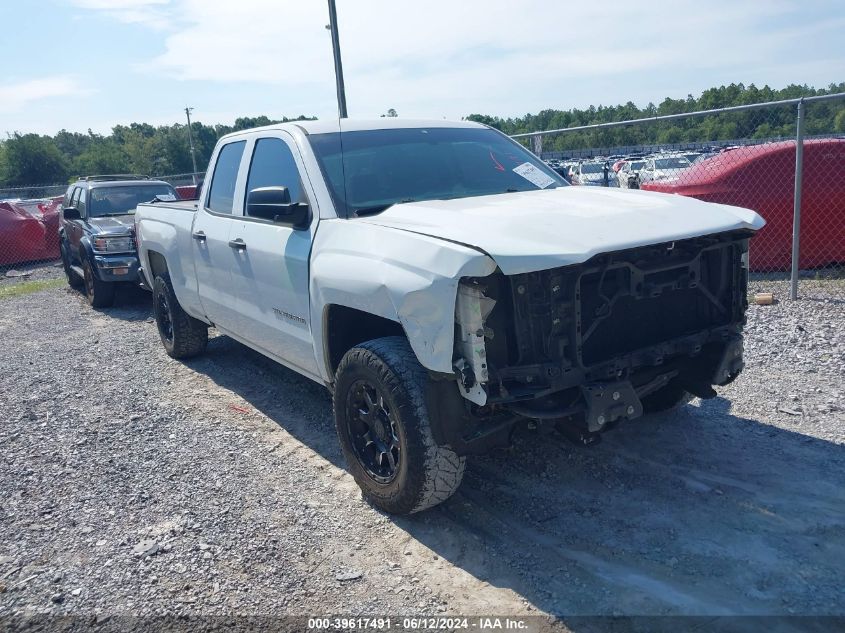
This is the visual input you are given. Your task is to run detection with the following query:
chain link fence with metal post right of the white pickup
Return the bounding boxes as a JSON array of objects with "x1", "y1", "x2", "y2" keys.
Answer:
[{"x1": 514, "y1": 94, "x2": 845, "y2": 300}]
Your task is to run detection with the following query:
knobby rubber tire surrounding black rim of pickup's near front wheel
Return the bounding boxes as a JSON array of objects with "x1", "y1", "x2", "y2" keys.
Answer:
[{"x1": 333, "y1": 337, "x2": 466, "y2": 514}]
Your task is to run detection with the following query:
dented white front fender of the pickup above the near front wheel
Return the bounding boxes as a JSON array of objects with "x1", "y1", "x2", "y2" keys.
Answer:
[{"x1": 310, "y1": 219, "x2": 496, "y2": 380}]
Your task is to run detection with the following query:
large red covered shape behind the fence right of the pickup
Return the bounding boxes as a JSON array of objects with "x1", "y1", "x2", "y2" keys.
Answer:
[{"x1": 642, "y1": 139, "x2": 845, "y2": 272}]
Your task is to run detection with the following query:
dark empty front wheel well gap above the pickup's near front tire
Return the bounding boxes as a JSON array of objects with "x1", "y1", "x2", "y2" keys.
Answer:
[{"x1": 323, "y1": 305, "x2": 405, "y2": 375}]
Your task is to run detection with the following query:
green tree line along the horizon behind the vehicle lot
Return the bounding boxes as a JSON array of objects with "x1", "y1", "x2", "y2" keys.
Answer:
[{"x1": 0, "y1": 82, "x2": 845, "y2": 187}]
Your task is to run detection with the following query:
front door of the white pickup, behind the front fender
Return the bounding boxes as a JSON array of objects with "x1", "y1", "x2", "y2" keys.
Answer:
[{"x1": 229, "y1": 131, "x2": 318, "y2": 375}]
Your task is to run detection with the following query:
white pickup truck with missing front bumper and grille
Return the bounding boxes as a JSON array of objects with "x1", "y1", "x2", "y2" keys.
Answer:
[{"x1": 135, "y1": 119, "x2": 763, "y2": 513}]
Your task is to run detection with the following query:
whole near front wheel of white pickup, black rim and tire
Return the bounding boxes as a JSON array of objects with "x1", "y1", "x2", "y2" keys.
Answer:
[{"x1": 334, "y1": 337, "x2": 466, "y2": 514}]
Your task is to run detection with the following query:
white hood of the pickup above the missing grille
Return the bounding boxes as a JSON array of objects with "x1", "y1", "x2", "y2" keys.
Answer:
[{"x1": 354, "y1": 187, "x2": 765, "y2": 275}]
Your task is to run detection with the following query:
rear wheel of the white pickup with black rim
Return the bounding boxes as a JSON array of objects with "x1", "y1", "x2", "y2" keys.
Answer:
[{"x1": 153, "y1": 273, "x2": 208, "y2": 359}]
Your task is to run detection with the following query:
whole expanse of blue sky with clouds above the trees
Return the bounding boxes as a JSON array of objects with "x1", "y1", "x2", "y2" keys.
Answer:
[{"x1": 0, "y1": 0, "x2": 845, "y2": 134}]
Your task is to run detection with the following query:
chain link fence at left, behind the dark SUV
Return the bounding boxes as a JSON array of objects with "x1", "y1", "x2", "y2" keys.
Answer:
[{"x1": 0, "y1": 173, "x2": 204, "y2": 279}]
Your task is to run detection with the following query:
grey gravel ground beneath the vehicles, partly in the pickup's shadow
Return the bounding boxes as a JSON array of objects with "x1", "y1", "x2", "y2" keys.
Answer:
[{"x1": 0, "y1": 268, "x2": 845, "y2": 617}]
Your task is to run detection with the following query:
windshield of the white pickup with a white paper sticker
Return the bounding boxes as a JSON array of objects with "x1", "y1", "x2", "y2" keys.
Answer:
[{"x1": 309, "y1": 127, "x2": 567, "y2": 216}]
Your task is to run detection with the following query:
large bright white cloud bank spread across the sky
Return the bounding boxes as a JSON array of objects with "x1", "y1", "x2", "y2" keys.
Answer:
[{"x1": 64, "y1": 0, "x2": 841, "y2": 123}]
